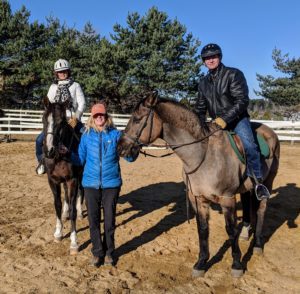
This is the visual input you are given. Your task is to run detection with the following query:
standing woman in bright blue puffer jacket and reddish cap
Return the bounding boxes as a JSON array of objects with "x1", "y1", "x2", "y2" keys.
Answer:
[{"x1": 79, "y1": 102, "x2": 136, "y2": 267}]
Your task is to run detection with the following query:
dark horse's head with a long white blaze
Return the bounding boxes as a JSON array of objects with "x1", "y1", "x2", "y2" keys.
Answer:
[{"x1": 43, "y1": 99, "x2": 72, "y2": 158}]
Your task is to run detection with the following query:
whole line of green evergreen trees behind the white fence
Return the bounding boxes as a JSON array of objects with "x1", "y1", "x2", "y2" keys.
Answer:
[{"x1": 0, "y1": 0, "x2": 300, "y2": 113}]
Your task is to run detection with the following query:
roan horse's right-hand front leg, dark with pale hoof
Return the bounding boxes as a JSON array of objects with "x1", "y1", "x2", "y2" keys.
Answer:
[{"x1": 220, "y1": 197, "x2": 244, "y2": 277}]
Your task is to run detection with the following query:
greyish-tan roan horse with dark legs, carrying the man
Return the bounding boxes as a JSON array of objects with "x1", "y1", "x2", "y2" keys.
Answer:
[{"x1": 118, "y1": 94, "x2": 280, "y2": 277}]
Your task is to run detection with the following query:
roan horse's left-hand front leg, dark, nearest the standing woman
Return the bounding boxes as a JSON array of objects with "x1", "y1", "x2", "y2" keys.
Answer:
[{"x1": 190, "y1": 196, "x2": 209, "y2": 277}]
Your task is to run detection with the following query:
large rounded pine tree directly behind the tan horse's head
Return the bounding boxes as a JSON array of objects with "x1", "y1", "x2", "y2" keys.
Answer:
[{"x1": 111, "y1": 7, "x2": 200, "y2": 110}]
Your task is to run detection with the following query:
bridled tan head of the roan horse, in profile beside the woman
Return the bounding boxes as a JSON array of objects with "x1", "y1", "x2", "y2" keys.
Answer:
[{"x1": 118, "y1": 93, "x2": 162, "y2": 157}]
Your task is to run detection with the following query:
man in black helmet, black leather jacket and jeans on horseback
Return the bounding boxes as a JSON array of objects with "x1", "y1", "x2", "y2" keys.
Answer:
[{"x1": 195, "y1": 44, "x2": 270, "y2": 240}]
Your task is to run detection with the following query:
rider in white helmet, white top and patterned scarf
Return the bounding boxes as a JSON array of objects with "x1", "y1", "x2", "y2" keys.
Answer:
[{"x1": 36, "y1": 59, "x2": 85, "y2": 175}]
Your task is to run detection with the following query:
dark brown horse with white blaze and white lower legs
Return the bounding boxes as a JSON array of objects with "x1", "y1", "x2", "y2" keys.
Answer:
[{"x1": 43, "y1": 98, "x2": 83, "y2": 255}]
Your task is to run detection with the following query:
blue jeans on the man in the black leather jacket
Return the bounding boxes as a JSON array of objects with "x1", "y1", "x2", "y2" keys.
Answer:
[{"x1": 234, "y1": 117, "x2": 262, "y2": 179}]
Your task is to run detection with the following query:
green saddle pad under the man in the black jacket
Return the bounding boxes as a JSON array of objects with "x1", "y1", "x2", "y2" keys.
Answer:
[{"x1": 226, "y1": 131, "x2": 270, "y2": 164}]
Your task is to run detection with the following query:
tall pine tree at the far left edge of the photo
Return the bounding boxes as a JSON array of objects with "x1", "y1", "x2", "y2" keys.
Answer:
[{"x1": 0, "y1": 0, "x2": 52, "y2": 107}]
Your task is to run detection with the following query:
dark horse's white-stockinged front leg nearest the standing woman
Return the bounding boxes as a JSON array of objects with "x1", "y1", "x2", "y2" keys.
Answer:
[{"x1": 67, "y1": 179, "x2": 78, "y2": 255}]
